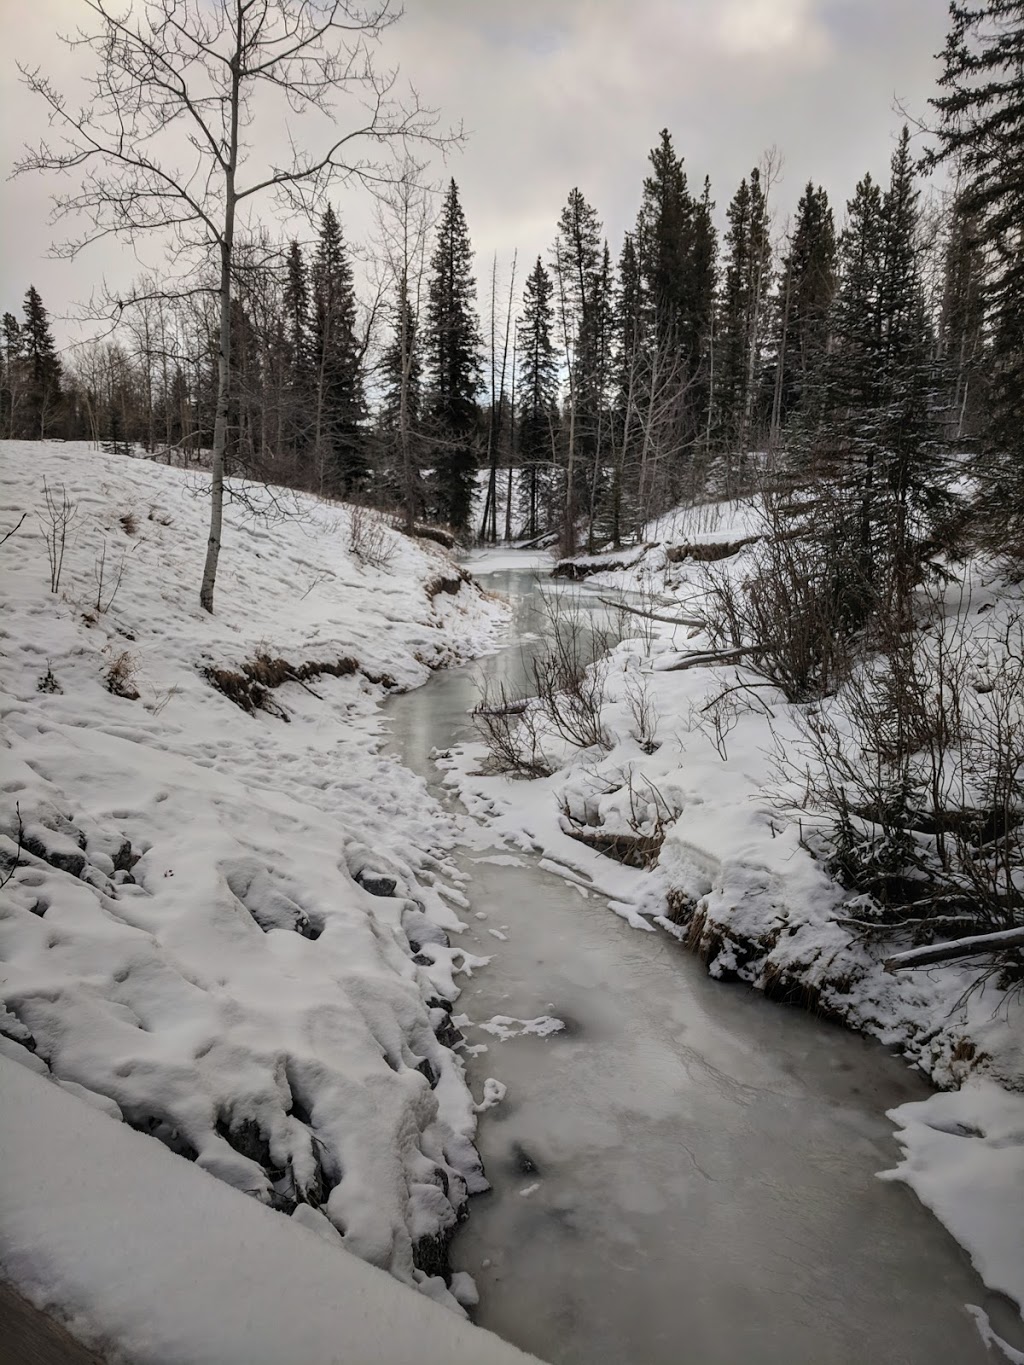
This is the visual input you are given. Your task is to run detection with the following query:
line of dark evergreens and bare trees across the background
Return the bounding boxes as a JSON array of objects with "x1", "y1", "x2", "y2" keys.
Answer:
[{"x1": 10, "y1": 0, "x2": 1024, "y2": 588}]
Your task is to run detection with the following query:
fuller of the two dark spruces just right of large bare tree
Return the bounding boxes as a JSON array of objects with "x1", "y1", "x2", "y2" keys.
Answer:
[{"x1": 310, "y1": 205, "x2": 367, "y2": 497}]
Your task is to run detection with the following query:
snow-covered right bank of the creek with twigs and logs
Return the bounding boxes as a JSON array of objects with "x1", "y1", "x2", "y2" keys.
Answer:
[{"x1": 442, "y1": 504, "x2": 1024, "y2": 1309}]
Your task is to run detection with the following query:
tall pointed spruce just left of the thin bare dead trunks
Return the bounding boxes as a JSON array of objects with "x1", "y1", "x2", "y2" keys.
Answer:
[{"x1": 423, "y1": 180, "x2": 483, "y2": 530}]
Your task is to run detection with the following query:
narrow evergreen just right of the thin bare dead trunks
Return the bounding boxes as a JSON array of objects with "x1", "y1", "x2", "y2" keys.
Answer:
[{"x1": 517, "y1": 255, "x2": 558, "y2": 536}]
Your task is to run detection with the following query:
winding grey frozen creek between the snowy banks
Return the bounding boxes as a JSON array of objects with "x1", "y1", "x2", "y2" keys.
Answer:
[{"x1": 385, "y1": 569, "x2": 1020, "y2": 1365}]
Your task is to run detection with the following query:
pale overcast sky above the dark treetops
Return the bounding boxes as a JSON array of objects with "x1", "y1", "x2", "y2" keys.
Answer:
[{"x1": 0, "y1": 0, "x2": 948, "y2": 346}]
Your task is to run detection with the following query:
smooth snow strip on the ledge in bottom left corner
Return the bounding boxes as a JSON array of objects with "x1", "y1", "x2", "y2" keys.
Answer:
[{"x1": 0, "y1": 1057, "x2": 532, "y2": 1365}]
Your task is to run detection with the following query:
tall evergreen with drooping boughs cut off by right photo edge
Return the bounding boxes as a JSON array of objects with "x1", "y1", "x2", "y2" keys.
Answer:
[{"x1": 928, "y1": 0, "x2": 1024, "y2": 534}]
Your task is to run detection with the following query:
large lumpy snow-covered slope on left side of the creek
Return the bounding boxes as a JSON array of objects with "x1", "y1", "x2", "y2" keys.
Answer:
[{"x1": 0, "y1": 442, "x2": 513, "y2": 1306}]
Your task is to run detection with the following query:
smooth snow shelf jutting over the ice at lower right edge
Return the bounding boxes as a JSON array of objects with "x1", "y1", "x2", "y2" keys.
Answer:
[{"x1": 883, "y1": 1080, "x2": 1024, "y2": 1316}]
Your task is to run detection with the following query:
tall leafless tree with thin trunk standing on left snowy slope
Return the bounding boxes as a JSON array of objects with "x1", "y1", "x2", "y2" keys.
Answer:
[{"x1": 15, "y1": 0, "x2": 452, "y2": 612}]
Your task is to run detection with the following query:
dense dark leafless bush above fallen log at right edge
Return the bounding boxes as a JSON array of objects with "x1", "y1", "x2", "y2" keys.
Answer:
[{"x1": 778, "y1": 597, "x2": 1024, "y2": 980}]
